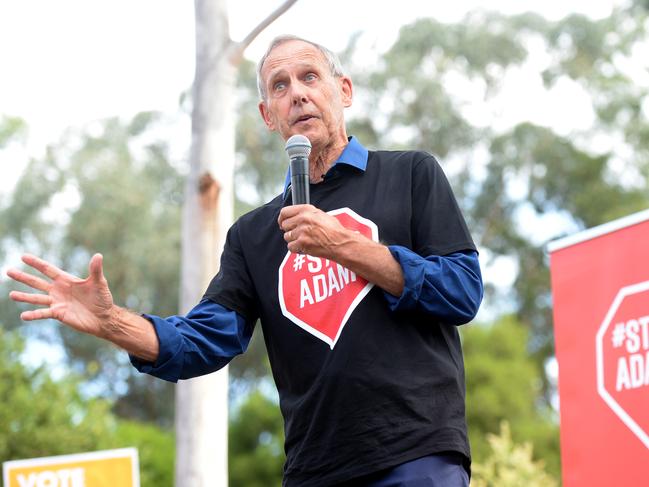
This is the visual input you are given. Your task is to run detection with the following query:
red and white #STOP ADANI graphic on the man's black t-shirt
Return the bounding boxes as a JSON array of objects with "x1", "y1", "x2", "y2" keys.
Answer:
[{"x1": 278, "y1": 208, "x2": 379, "y2": 349}]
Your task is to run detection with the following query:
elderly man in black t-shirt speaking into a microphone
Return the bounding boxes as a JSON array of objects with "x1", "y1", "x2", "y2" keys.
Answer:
[{"x1": 9, "y1": 36, "x2": 482, "y2": 487}]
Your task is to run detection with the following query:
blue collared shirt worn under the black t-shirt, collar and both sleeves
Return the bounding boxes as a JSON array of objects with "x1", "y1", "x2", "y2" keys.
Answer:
[{"x1": 131, "y1": 137, "x2": 483, "y2": 382}]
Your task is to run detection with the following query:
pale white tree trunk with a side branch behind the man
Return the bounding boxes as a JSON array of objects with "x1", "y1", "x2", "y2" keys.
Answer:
[{"x1": 175, "y1": 0, "x2": 297, "y2": 487}]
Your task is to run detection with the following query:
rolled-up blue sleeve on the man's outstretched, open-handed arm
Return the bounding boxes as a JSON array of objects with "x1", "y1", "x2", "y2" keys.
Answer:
[{"x1": 130, "y1": 299, "x2": 254, "y2": 382}]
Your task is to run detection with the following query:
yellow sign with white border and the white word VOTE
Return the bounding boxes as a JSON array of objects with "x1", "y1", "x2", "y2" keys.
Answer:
[{"x1": 2, "y1": 448, "x2": 140, "y2": 487}]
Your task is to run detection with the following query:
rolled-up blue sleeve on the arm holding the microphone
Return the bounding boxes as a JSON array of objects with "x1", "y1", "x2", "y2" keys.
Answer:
[{"x1": 384, "y1": 245, "x2": 483, "y2": 325}]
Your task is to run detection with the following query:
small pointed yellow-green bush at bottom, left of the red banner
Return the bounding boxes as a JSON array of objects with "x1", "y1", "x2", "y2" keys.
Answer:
[{"x1": 471, "y1": 421, "x2": 559, "y2": 487}]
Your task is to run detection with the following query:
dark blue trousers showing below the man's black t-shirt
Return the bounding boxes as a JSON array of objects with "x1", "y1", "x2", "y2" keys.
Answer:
[{"x1": 340, "y1": 454, "x2": 469, "y2": 487}]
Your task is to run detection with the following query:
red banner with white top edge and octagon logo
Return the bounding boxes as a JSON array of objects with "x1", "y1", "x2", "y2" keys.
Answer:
[{"x1": 548, "y1": 210, "x2": 649, "y2": 487}]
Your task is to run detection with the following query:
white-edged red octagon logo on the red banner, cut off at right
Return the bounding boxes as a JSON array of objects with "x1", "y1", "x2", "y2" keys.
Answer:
[{"x1": 596, "y1": 281, "x2": 649, "y2": 448}]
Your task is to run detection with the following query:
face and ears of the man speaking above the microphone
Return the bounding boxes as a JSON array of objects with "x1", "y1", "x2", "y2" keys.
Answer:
[{"x1": 259, "y1": 41, "x2": 352, "y2": 148}]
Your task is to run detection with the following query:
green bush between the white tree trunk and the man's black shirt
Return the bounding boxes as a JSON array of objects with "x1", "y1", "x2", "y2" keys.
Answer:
[{"x1": 228, "y1": 391, "x2": 284, "y2": 487}]
